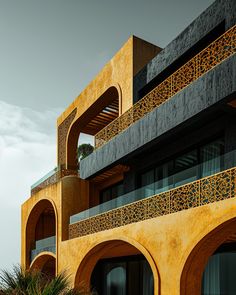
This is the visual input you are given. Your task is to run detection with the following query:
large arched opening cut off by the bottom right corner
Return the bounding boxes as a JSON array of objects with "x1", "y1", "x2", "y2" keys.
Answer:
[{"x1": 181, "y1": 218, "x2": 236, "y2": 295}]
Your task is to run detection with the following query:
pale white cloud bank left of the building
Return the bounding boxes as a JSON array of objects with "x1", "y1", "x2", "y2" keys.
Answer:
[{"x1": 0, "y1": 101, "x2": 61, "y2": 268}]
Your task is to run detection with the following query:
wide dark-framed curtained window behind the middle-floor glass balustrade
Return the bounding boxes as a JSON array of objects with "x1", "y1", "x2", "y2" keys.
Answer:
[{"x1": 139, "y1": 138, "x2": 224, "y2": 196}]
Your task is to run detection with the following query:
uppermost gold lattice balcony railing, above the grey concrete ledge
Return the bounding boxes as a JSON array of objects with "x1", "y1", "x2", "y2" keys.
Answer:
[{"x1": 95, "y1": 26, "x2": 236, "y2": 148}]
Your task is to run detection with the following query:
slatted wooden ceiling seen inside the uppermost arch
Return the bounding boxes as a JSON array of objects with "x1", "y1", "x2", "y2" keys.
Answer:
[{"x1": 82, "y1": 99, "x2": 119, "y2": 135}]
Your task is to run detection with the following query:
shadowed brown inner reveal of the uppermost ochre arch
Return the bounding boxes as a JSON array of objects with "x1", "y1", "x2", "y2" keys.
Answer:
[{"x1": 66, "y1": 84, "x2": 122, "y2": 169}]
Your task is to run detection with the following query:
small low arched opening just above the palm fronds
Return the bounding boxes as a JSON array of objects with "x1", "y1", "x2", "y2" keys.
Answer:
[{"x1": 30, "y1": 253, "x2": 56, "y2": 279}]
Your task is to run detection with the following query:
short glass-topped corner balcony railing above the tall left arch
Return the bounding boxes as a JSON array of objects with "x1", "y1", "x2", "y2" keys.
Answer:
[{"x1": 31, "y1": 167, "x2": 79, "y2": 195}]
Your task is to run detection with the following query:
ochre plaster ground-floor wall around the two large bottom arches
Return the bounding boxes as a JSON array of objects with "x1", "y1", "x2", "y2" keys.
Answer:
[{"x1": 58, "y1": 198, "x2": 236, "y2": 295}]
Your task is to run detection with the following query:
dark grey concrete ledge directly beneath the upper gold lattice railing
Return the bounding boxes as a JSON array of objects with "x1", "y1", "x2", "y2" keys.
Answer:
[{"x1": 80, "y1": 55, "x2": 236, "y2": 179}]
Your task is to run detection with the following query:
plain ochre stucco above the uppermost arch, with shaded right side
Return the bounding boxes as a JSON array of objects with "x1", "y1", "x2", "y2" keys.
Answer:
[{"x1": 57, "y1": 36, "x2": 161, "y2": 125}]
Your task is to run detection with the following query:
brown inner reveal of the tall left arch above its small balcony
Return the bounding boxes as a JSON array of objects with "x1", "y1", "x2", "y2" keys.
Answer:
[{"x1": 25, "y1": 199, "x2": 58, "y2": 268}]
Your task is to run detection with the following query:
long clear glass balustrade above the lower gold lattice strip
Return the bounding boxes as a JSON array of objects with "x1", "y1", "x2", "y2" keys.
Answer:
[{"x1": 70, "y1": 151, "x2": 236, "y2": 224}]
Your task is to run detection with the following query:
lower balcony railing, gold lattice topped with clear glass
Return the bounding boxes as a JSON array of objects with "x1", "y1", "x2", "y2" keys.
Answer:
[{"x1": 69, "y1": 151, "x2": 236, "y2": 238}]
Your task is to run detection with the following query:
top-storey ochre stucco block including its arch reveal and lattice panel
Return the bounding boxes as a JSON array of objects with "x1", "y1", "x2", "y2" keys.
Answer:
[{"x1": 57, "y1": 36, "x2": 161, "y2": 167}]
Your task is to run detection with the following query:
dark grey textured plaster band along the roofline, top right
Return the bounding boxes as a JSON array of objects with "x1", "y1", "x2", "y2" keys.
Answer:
[{"x1": 134, "y1": 0, "x2": 236, "y2": 101}]
